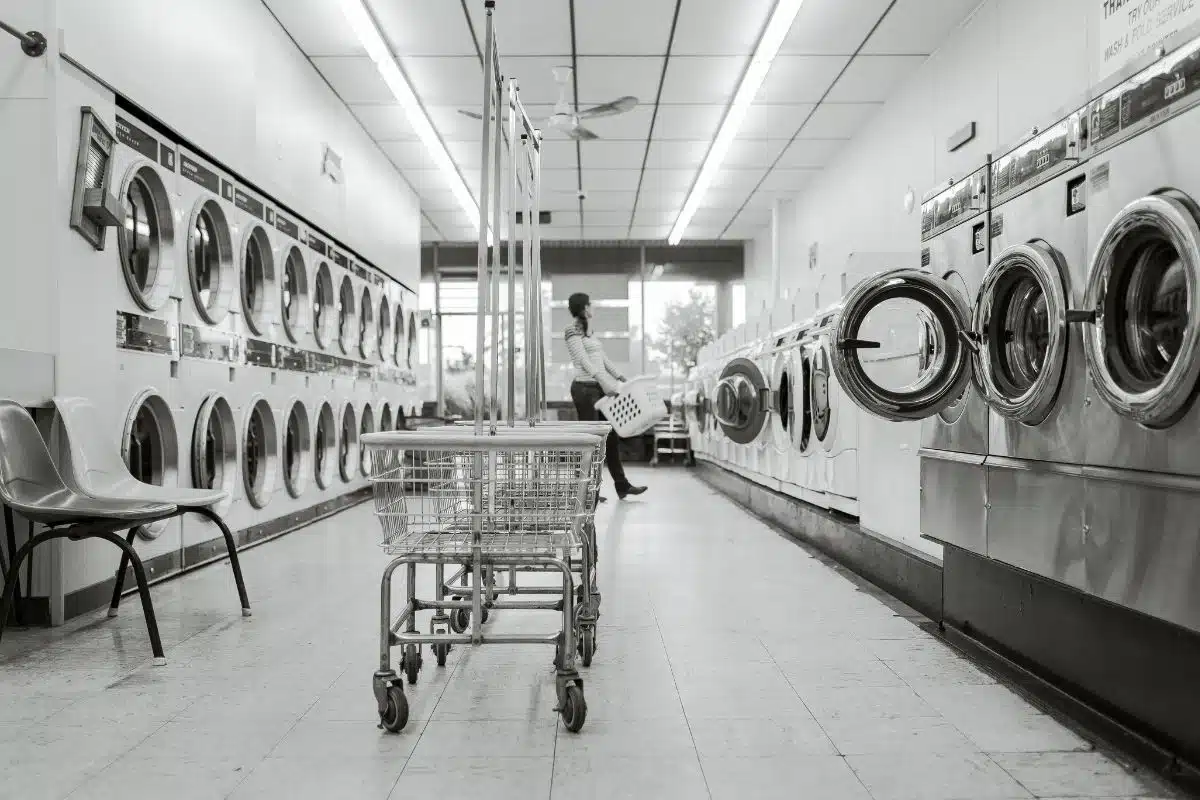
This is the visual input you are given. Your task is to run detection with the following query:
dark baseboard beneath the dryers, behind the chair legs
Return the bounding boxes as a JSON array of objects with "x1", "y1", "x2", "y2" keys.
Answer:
[{"x1": 60, "y1": 488, "x2": 371, "y2": 625}]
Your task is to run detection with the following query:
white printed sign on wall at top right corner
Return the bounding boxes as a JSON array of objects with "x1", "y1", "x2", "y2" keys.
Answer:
[{"x1": 1088, "y1": 0, "x2": 1200, "y2": 82}]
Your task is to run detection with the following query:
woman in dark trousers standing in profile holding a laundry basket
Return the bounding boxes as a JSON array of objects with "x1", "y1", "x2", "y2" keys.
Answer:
[{"x1": 565, "y1": 291, "x2": 646, "y2": 501}]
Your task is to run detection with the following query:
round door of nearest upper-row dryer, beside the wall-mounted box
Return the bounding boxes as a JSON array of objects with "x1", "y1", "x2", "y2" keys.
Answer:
[{"x1": 116, "y1": 164, "x2": 175, "y2": 311}]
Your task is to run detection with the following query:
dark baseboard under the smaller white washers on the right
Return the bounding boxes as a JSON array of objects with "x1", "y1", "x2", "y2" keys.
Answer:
[{"x1": 697, "y1": 461, "x2": 942, "y2": 620}]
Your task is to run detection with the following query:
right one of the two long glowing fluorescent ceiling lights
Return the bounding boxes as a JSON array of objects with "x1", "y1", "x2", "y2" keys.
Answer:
[{"x1": 667, "y1": 0, "x2": 804, "y2": 245}]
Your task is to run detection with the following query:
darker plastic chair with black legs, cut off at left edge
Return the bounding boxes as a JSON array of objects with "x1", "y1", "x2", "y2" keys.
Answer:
[{"x1": 0, "y1": 399, "x2": 178, "y2": 664}]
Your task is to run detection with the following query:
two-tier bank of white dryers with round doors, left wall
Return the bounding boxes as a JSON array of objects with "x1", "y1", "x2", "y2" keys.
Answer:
[{"x1": 55, "y1": 61, "x2": 419, "y2": 593}]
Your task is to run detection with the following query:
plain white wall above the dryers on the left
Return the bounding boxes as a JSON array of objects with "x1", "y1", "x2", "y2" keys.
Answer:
[{"x1": 56, "y1": 0, "x2": 420, "y2": 290}]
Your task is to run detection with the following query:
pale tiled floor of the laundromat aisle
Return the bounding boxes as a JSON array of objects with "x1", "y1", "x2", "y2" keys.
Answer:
[{"x1": 0, "y1": 469, "x2": 1174, "y2": 800}]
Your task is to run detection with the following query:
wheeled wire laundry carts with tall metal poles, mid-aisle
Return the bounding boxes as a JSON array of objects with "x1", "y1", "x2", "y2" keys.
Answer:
[{"x1": 362, "y1": 0, "x2": 600, "y2": 732}]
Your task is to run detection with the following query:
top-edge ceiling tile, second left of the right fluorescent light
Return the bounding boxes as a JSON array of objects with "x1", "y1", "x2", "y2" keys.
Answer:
[{"x1": 578, "y1": 0, "x2": 674, "y2": 55}]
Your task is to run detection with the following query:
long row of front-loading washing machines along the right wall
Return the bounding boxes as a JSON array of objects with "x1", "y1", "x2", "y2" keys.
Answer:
[{"x1": 691, "y1": 20, "x2": 1200, "y2": 631}]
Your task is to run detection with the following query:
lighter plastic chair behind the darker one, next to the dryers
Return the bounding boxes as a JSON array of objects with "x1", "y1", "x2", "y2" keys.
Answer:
[{"x1": 54, "y1": 397, "x2": 250, "y2": 616}]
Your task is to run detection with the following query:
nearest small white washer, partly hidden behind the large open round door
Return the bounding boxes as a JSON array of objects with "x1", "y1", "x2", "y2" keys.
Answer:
[{"x1": 809, "y1": 305, "x2": 859, "y2": 517}]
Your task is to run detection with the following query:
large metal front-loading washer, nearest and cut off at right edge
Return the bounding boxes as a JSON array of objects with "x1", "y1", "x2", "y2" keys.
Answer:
[{"x1": 1060, "y1": 32, "x2": 1200, "y2": 631}]
